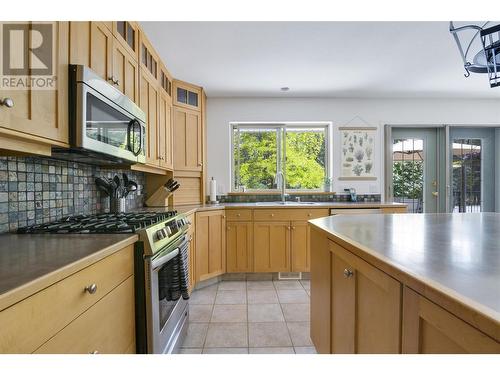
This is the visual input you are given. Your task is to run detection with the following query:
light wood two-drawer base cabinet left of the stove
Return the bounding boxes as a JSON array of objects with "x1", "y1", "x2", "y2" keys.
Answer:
[{"x1": 0, "y1": 245, "x2": 135, "y2": 354}]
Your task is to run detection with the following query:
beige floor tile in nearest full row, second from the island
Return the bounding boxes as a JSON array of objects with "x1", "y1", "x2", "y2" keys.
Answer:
[{"x1": 248, "y1": 322, "x2": 291, "y2": 348}]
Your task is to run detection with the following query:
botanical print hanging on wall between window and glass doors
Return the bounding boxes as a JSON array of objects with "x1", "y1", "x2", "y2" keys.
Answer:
[{"x1": 339, "y1": 127, "x2": 377, "y2": 180}]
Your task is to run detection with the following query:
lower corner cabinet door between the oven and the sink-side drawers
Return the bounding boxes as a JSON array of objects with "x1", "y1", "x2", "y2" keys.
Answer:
[{"x1": 195, "y1": 211, "x2": 226, "y2": 281}]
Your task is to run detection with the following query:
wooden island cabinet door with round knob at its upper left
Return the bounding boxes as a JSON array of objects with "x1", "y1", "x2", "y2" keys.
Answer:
[{"x1": 330, "y1": 242, "x2": 401, "y2": 353}]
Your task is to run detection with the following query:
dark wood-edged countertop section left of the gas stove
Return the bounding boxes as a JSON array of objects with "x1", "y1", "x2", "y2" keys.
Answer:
[{"x1": 0, "y1": 234, "x2": 138, "y2": 310}]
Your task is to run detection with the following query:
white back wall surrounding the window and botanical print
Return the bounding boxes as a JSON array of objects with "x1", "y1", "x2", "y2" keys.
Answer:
[{"x1": 207, "y1": 97, "x2": 500, "y2": 197}]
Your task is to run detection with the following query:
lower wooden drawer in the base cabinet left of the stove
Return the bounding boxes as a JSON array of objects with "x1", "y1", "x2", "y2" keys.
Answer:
[{"x1": 35, "y1": 276, "x2": 135, "y2": 354}]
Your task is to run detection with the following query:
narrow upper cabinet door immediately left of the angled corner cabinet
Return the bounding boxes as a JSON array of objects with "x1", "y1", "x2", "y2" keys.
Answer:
[{"x1": 158, "y1": 90, "x2": 173, "y2": 169}]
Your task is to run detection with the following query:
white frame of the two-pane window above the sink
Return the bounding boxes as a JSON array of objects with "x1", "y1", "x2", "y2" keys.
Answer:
[{"x1": 229, "y1": 121, "x2": 333, "y2": 193}]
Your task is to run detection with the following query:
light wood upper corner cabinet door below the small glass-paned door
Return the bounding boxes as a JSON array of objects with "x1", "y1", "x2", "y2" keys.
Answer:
[{"x1": 174, "y1": 106, "x2": 203, "y2": 171}]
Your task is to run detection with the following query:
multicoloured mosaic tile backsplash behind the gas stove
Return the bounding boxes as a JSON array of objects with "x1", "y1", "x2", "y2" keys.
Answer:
[{"x1": 0, "y1": 157, "x2": 145, "y2": 233}]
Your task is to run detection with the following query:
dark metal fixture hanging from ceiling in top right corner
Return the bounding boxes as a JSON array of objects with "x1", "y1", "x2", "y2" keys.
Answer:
[{"x1": 450, "y1": 21, "x2": 500, "y2": 87}]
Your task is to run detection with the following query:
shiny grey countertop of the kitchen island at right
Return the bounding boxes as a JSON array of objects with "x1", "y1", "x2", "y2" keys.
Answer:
[{"x1": 310, "y1": 213, "x2": 500, "y2": 332}]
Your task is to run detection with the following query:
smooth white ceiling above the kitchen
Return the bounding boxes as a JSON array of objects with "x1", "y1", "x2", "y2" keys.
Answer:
[{"x1": 141, "y1": 22, "x2": 500, "y2": 98}]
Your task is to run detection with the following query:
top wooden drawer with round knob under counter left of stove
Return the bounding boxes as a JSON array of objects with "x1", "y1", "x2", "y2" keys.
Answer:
[{"x1": 0, "y1": 245, "x2": 134, "y2": 353}]
